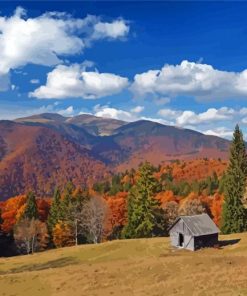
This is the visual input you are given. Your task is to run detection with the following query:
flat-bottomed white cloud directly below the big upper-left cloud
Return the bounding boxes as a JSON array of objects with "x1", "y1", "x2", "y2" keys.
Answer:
[{"x1": 29, "y1": 64, "x2": 128, "y2": 99}]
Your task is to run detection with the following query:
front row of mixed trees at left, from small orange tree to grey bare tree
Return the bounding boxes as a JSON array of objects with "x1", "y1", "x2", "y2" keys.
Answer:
[{"x1": 1, "y1": 186, "x2": 107, "y2": 254}]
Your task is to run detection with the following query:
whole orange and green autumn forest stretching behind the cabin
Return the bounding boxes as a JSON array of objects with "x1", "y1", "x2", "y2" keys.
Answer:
[{"x1": 0, "y1": 122, "x2": 246, "y2": 256}]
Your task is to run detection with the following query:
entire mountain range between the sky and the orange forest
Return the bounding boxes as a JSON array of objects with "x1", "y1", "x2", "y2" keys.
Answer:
[{"x1": 0, "y1": 113, "x2": 229, "y2": 200}]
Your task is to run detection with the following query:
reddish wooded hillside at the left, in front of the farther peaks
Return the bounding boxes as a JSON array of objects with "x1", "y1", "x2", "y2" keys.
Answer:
[{"x1": 0, "y1": 121, "x2": 107, "y2": 199}]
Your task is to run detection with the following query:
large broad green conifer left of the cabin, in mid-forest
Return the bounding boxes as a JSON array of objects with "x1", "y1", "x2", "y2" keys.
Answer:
[{"x1": 123, "y1": 162, "x2": 164, "y2": 238}]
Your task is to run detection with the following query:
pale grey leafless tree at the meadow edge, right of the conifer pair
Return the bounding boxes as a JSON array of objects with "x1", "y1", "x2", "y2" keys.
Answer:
[{"x1": 77, "y1": 197, "x2": 107, "y2": 244}]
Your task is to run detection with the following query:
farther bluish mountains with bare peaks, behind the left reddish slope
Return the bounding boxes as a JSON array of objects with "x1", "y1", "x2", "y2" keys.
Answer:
[{"x1": 13, "y1": 113, "x2": 229, "y2": 170}]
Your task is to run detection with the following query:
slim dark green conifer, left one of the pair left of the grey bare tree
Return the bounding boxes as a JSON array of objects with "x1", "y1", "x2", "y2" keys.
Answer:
[{"x1": 47, "y1": 188, "x2": 61, "y2": 233}]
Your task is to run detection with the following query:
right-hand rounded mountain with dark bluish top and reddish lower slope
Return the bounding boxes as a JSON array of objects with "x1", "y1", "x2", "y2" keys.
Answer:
[{"x1": 112, "y1": 120, "x2": 229, "y2": 170}]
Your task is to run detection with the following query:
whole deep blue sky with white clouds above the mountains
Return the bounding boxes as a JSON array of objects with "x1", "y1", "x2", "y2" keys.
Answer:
[{"x1": 0, "y1": 1, "x2": 247, "y2": 139}]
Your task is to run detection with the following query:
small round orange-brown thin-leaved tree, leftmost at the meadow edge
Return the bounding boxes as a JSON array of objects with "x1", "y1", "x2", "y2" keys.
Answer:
[{"x1": 14, "y1": 218, "x2": 48, "y2": 254}]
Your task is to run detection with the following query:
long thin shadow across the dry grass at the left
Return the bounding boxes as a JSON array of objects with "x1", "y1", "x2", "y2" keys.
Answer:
[{"x1": 0, "y1": 257, "x2": 79, "y2": 275}]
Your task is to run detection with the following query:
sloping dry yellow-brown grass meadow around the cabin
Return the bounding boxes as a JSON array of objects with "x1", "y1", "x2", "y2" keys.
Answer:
[{"x1": 0, "y1": 234, "x2": 247, "y2": 296}]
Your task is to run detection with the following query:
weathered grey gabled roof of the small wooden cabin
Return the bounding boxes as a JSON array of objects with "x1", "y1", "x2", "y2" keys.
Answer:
[{"x1": 169, "y1": 214, "x2": 220, "y2": 236}]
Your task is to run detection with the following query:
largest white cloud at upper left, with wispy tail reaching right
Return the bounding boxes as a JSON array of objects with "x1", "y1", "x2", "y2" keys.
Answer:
[{"x1": 0, "y1": 8, "x2": 129, "y2": 75}]
